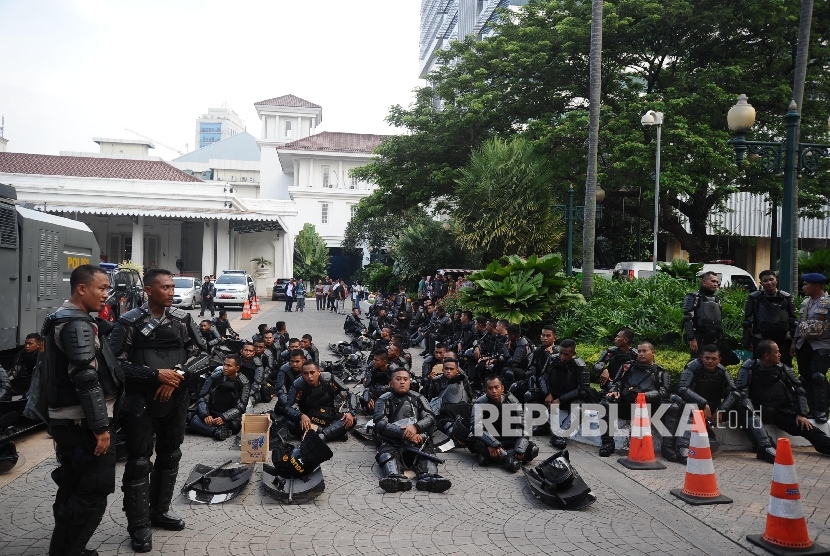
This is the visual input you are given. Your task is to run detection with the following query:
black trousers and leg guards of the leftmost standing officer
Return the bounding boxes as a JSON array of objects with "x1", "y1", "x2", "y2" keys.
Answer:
[{"x1": 49, "y1": 419, "x2": 115, "y2": 556}]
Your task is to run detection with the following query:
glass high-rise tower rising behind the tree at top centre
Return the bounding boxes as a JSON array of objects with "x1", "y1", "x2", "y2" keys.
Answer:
[{"x1": 418, "y1": 0, "x2": 527, "y2": 79}]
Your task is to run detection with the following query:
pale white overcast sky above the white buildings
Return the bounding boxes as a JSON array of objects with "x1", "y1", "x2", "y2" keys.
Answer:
[{"x1": 0, "y1": 0, "x2": 421, "y2": 160}]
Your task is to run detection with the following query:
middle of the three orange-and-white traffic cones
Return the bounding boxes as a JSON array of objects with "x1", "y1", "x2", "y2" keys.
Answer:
[{"x1": 670, "y1": 409, "x2": 732, "y2": 506}]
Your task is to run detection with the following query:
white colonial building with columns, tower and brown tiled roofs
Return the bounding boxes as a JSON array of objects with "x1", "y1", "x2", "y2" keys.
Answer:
[{"x1": 0, "y1": 95, "x2": 383, "y2": 288}]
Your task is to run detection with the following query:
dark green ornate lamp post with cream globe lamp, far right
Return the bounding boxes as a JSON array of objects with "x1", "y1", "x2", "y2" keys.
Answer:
[{"x1": 726, "y1": 95, "x2": 830, "y2": 291}]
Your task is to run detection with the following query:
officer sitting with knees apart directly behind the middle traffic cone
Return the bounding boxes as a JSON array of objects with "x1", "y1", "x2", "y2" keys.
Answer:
[{"x1": 666, "y1": 344, "x2": 775, "y2": 463}]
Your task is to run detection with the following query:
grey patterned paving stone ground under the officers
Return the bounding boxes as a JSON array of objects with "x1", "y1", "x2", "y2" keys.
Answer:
[{"x1": 0, "y1": 302, "x2": 830, "y2": 556}]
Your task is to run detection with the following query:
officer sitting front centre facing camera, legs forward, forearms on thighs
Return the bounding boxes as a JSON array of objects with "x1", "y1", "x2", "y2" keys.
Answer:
[{"x1": 373, "y1": 369, "x2": 452, "y2": 492}]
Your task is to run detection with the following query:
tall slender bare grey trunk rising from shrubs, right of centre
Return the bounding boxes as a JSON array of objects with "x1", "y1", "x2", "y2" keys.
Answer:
[{"x1": 582, "y1": 0, "x2": 603, "y2": 297}]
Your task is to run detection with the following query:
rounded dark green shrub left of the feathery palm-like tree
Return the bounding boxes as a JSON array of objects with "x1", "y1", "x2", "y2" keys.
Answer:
[{"x1": 391, "y1": 218, "x2": 474, "y2": 281}]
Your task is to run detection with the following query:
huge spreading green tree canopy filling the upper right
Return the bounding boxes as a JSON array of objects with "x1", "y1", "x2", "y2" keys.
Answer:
[{"x1": 357, "y1": 0, "x2": 830, "y2": 260}]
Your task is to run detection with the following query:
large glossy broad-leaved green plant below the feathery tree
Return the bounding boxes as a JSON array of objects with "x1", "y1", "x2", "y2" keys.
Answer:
[{"x1": 461, "y1": 254, "x2": 585, "y2": 324}]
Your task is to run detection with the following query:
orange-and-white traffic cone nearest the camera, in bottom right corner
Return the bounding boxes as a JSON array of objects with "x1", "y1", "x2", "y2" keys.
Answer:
[{"x1": 746, "y1": 438, "x2": 830, "y2": 555}]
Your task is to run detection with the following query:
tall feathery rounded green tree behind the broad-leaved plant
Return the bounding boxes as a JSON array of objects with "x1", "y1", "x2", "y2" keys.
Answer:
[{"x1": 452, "y1": 137, "x2": 562, "y2": 259}]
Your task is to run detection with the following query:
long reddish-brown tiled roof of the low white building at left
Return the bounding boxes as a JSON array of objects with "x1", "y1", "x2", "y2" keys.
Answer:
[{"x1": 0, "y1": 153, "x2": 202, "y2": 182}]
